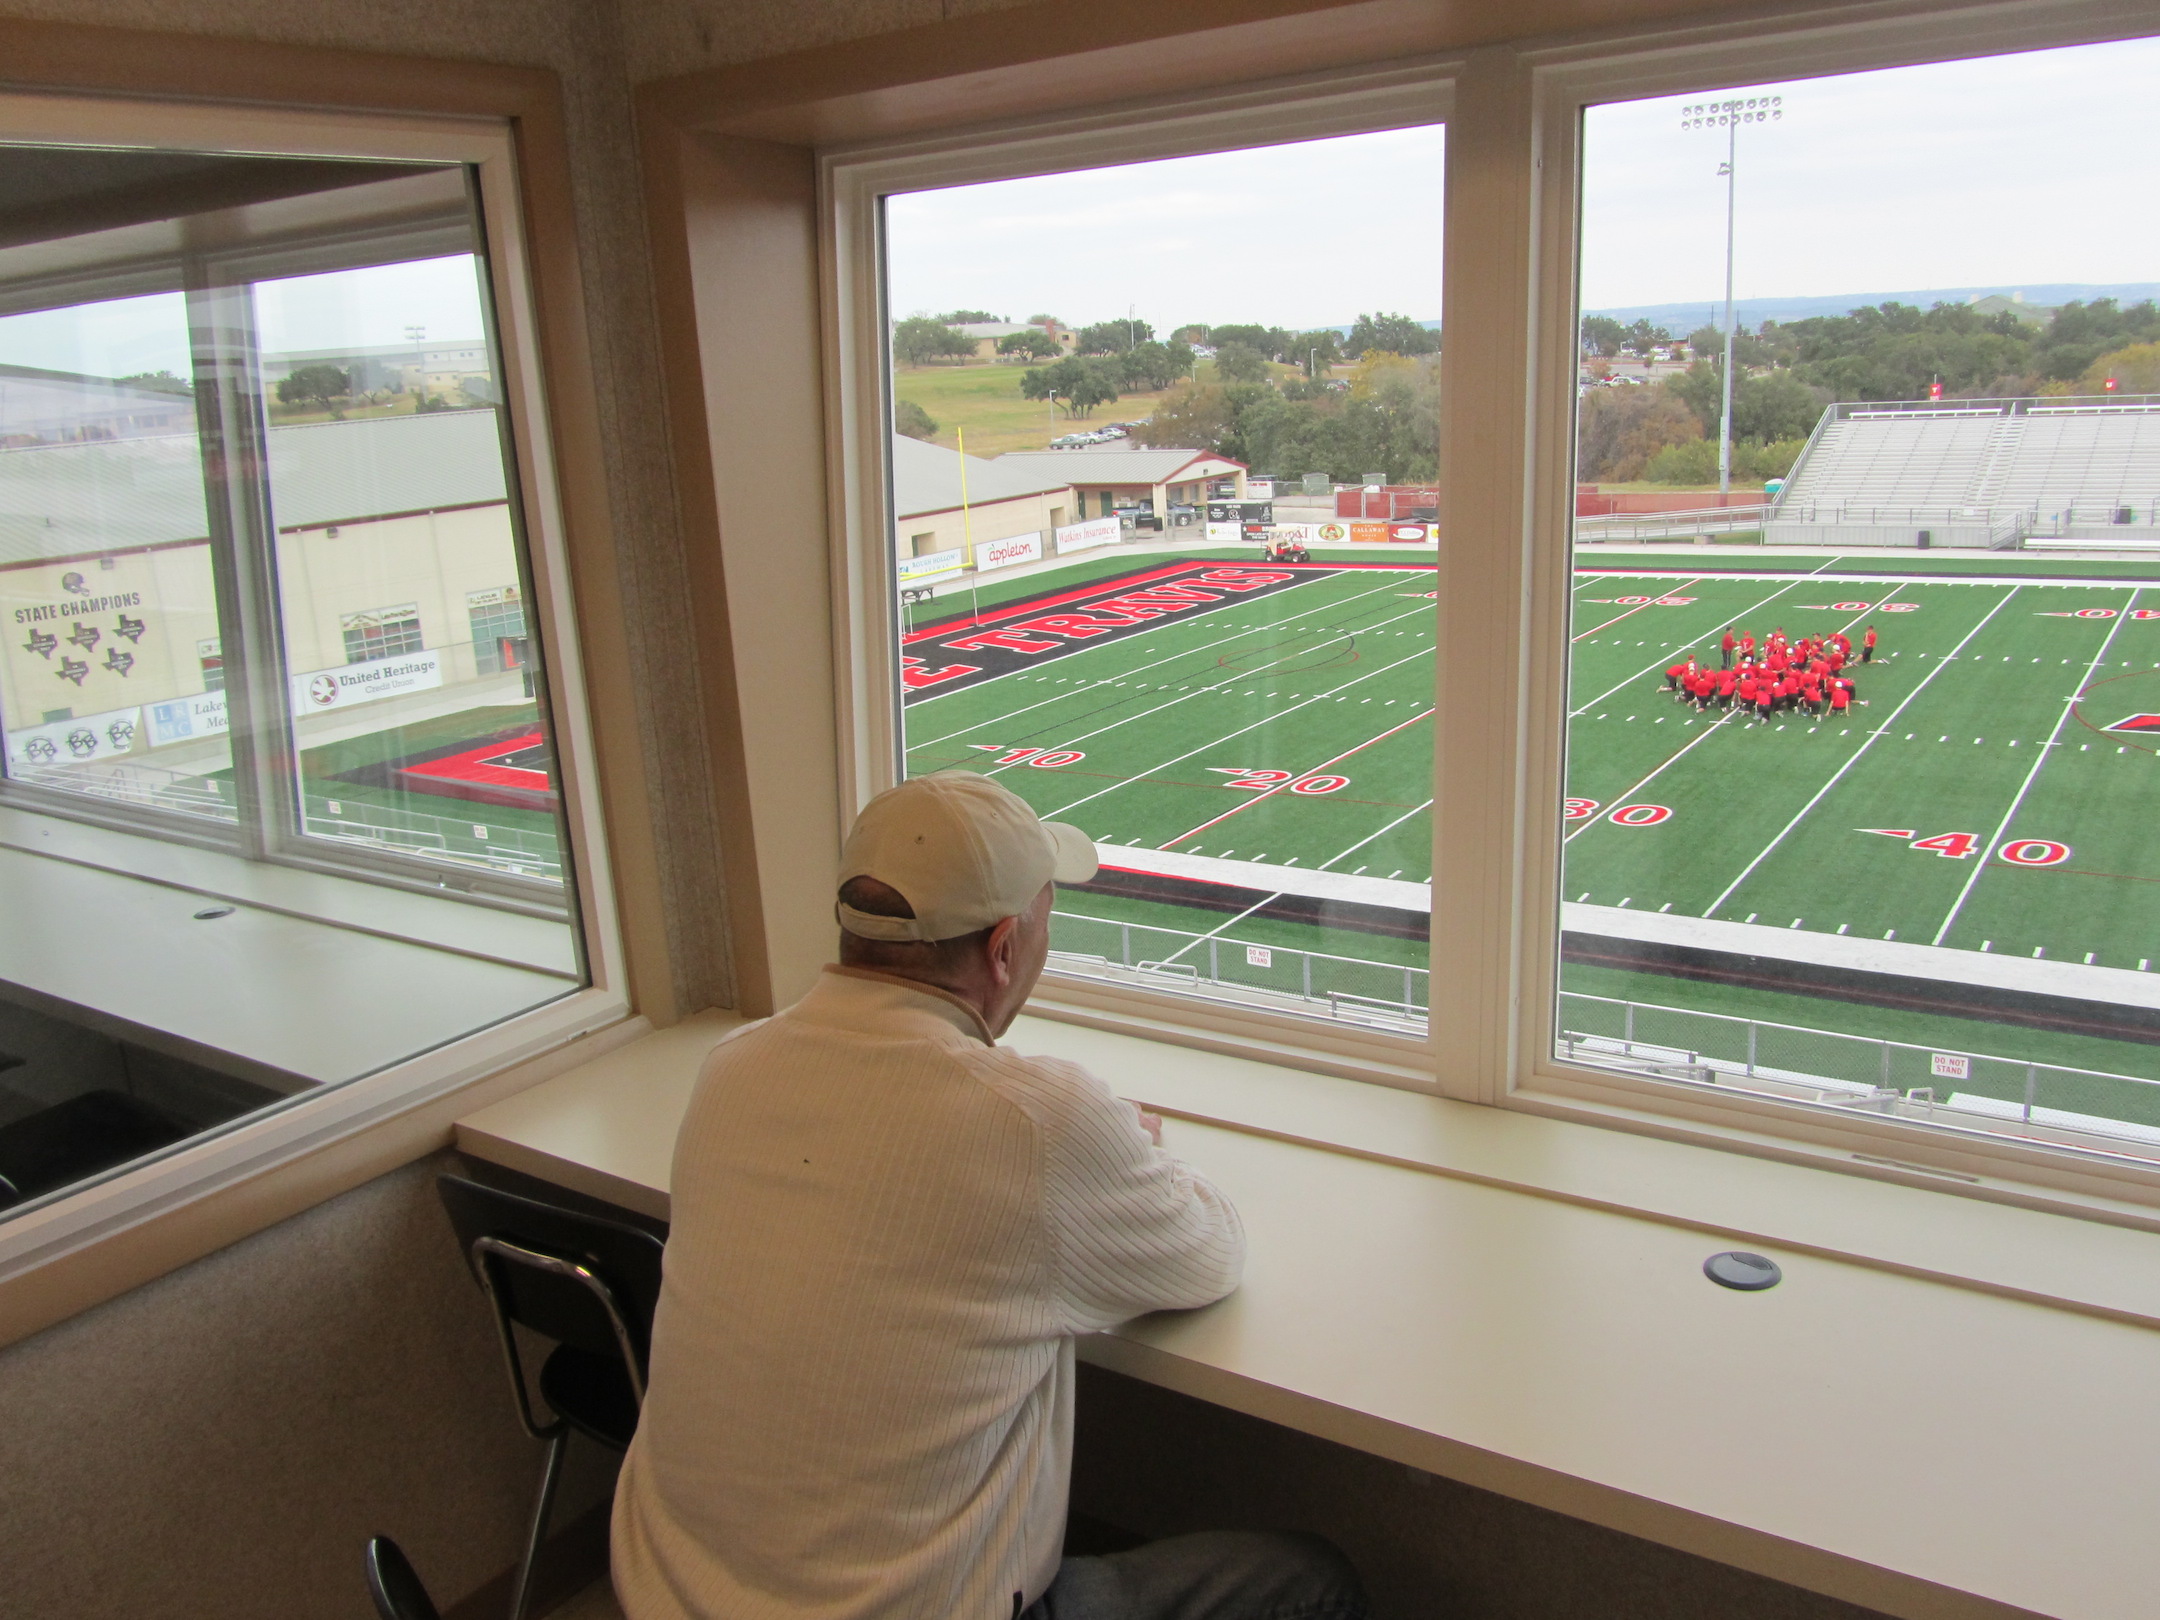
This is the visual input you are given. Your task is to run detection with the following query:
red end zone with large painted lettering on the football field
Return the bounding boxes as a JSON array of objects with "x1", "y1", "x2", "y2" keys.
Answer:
[{"x1": 901, "y1": 565, "x2": 1326, "y2": 700}]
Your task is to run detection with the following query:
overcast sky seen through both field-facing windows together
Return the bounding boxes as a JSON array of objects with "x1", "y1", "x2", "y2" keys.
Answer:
[{"x1": 888, "y1": 41, "x2": 2160, "y2": 330}]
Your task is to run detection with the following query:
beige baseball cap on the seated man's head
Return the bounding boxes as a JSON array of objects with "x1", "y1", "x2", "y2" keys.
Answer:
[{"x1": 836, "y1": 771, "x2": 1095, "y2": 940}]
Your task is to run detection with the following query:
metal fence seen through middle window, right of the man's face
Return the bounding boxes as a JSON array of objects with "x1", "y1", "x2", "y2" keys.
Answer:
[{"x1": 1050, "y1": 912, "x2": 1430, "y2": 1026}]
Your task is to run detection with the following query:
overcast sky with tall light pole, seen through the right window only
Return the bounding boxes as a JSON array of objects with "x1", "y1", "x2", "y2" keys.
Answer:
[{"x1": 1583, "y1": 41, "x2": 2160, "y2": 309}]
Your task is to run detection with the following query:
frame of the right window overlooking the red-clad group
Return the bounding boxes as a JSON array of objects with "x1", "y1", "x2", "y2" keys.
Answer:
[{"x1": 1503, "y1": 0, "x2": 2160, "y2": 1203}]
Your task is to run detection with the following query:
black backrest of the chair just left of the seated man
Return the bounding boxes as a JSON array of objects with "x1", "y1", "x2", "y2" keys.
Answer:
[{"x1": 434, "y1": 1175, "x2": 665, "y2": 1387}]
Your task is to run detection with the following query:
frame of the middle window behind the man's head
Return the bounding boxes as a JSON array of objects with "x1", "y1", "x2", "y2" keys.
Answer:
[{"x1": 816, "y1": 54, "x2": 1462, "y2": 1091}]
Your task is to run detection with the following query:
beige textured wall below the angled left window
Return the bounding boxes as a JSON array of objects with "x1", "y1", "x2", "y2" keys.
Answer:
[{"x1": 0, "y1": 1156, "x2": 613, "y2": 1620}]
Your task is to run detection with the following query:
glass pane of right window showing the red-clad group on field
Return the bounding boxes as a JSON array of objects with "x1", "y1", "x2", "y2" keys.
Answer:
[{"x1": 1557, "y1": 41, "x2": 2160, "y2": 1156}]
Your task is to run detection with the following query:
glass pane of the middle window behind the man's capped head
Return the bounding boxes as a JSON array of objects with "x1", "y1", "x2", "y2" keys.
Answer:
[{"x1": 886, "y1": 125, "x2": 1443, "y2": 1032}]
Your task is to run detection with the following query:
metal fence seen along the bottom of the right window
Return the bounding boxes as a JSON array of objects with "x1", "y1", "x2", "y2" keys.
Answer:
[{"x1": 1560, "y1": 991, "x2": 2160, "y2": 1143}]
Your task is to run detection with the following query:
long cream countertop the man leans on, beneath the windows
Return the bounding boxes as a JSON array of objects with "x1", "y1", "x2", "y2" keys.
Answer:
[{"x1": 458, "y1": 1013, "x2": 2160, "y2": 1618}]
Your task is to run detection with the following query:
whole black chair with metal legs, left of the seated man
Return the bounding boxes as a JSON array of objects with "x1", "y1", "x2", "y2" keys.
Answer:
[{"x1": 436, "y1": 1175, "x2": 663, "y2": 1620}]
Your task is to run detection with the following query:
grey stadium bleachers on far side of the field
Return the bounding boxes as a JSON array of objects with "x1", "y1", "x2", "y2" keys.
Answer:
[{"x1": 1765, "y1": 395, "x2": 2160, "y2": 546}]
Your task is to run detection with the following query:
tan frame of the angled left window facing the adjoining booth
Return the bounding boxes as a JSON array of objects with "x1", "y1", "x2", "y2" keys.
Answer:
[{"x1": 0, "y1": 89, "x2": 631, "y2": 1285}]
